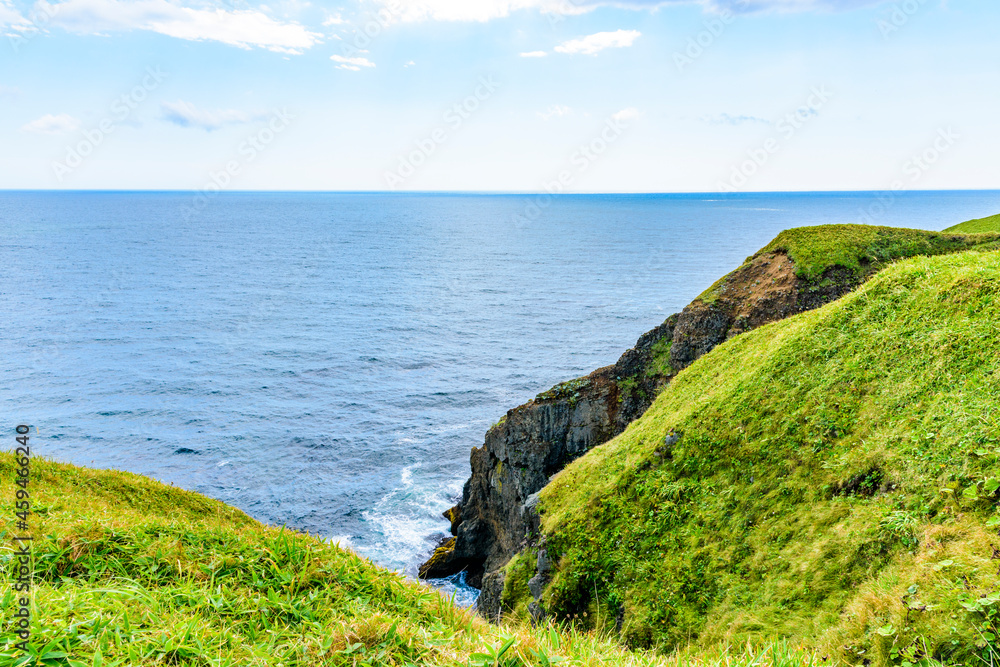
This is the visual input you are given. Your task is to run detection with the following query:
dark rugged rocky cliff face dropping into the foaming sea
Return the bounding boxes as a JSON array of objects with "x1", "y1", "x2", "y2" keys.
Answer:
[{"x1": 420, "y1": 252, "x2": 861, "y2": 619}]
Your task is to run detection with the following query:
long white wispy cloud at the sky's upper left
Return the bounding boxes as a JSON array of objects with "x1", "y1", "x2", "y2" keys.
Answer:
[{"x1": 37, "y1": 0, "x2": 321, "y2": 53}]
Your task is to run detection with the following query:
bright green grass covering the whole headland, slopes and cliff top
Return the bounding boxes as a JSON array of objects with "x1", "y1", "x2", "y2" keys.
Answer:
[{"x1": 0, "y1": 221, "x2": 1000, "y2": 667}]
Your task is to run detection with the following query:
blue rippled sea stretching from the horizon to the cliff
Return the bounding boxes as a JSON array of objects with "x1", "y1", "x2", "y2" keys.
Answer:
[{"x1": 0, "y1": 192, "x2": 1000, "y2": 600}]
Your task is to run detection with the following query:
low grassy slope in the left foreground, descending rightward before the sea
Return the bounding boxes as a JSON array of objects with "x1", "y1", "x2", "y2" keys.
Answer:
[{"x1": 0, "y1": 456, "x2": 805, "y2": 667}]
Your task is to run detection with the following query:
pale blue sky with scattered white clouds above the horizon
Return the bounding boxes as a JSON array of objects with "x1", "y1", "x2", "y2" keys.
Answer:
[{"x1": 0, "y1": 0, "x2": 1000, "y2": 193}]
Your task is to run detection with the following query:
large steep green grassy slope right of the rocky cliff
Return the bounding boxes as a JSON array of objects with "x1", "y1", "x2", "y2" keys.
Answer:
[{"x1": 528, "y1": 251, "x2": 1000, "y2": 665}]
